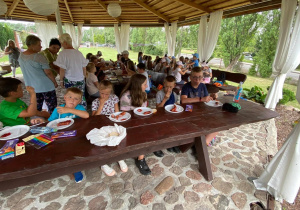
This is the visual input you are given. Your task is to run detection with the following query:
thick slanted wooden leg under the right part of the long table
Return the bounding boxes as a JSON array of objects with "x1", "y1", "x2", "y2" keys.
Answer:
[{"x1": 195, "y1": 136, "x2": 213, "y2": 181}]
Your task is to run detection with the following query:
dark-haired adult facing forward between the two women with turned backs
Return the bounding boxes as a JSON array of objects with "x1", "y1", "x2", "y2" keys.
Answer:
[{"x1": 41, "y1": 38, "x2": 61, "y2": 78}]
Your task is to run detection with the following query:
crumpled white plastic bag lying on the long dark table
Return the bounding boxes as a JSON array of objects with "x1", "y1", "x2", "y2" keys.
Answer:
[{"x1": 86, "y1": 124, "x2": 127, "y2": 146}]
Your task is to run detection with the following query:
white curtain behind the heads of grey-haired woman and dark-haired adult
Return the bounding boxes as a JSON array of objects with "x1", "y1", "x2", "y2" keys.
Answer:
[{"x1": 34, "y1": 20, "x2": 58, "y2": 49}]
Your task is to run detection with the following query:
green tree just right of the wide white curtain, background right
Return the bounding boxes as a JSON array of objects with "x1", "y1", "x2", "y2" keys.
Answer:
[{"x1": 219, "y1": 13, "x2": 259, "y2": 70}]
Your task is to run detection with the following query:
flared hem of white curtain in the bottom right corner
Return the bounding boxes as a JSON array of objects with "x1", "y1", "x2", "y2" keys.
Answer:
[{"x1": 253, "y1": 95, "x2": 300, "y2": 203}]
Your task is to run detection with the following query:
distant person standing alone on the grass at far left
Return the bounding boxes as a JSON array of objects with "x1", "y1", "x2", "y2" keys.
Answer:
[{"x1": 4, "y1": 39, "x2": 20, "y2": 77}]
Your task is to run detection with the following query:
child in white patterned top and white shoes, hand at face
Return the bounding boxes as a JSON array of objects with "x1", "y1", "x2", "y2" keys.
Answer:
[{"x1": 92, "y1": 80, "x2": 128, "y2": 176}]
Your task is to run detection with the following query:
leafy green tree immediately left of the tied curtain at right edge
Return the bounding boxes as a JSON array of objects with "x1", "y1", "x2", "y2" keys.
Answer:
[{"x1": 254, "y1": 10, "x2": 281, "y2": 77}]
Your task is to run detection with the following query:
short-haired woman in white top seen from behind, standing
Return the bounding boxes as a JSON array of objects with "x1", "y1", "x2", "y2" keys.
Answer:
[{"x1": 54, "y1": 33, "x2": 89, "y2": 108}]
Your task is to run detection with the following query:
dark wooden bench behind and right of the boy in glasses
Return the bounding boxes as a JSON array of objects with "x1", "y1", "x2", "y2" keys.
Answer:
[{"x1": 211, "y1": 69, "x2": 247, "y2": 91}]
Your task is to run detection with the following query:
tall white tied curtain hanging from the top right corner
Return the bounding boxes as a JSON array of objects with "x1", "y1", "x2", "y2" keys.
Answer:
[{"x1": 265, "y1": 0, "x2": 300, "y2": 109}]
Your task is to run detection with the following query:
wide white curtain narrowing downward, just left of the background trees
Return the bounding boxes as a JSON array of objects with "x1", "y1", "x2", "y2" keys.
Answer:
[{"x1": 198, "y1": 11, "x2": 223, "y2": 62}]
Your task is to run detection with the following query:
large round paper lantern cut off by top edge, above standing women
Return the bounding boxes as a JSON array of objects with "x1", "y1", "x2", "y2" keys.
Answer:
[{"x1": 23, "y1": 0, "x2": 58, "y2": 16}]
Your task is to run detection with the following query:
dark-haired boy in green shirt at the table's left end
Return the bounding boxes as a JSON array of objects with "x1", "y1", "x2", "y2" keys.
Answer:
[{"x1": 0, "y1": 77, "x2": 50, "y2": 126}]
